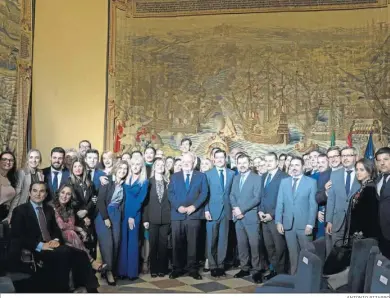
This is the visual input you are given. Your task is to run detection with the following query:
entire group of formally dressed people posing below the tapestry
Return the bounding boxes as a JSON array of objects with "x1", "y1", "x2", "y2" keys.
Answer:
[{"x1": 0, "y1": 138, "x2": 390, "y2": 292}]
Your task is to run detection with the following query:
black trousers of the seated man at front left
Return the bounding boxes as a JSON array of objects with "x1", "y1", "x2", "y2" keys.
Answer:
[{"x1": 35, "y1": 245, "x2": 99, "y2": 293}]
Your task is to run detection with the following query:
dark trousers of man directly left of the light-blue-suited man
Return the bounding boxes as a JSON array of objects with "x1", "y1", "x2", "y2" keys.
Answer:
[{"x1": 261, "y1": 220, "x2": 287, "y2": 274}]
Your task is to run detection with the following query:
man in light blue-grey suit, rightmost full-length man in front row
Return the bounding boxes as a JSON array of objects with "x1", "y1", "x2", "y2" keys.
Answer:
[{"x1": 275, "y1": 157, "x2": 318, "y2": 274}]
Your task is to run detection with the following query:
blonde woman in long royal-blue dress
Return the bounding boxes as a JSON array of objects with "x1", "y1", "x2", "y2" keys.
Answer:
[{"x1": 118, "y1": 156, "x2": 148, "y2": 280}]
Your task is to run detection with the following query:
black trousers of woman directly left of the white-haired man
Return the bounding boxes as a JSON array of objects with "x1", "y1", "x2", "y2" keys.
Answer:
[{"x1": 149, "y1": 224, "x2": 171, "y2": 274}]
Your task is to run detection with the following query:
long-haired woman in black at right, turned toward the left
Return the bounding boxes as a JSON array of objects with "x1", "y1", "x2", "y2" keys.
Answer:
[{"x1": 348, "y1": 158, "x2": 380, "y2": 238}]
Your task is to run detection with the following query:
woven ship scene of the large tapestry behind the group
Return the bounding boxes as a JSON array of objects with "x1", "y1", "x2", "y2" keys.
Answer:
[{"x1": 111, "y1": 19, "x2": 390, "y2": 156}]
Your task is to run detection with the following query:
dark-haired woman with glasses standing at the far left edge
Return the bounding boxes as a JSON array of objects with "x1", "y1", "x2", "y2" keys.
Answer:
[{"x1": 0, "y1": 151, "x2": 18, "y2": 221}]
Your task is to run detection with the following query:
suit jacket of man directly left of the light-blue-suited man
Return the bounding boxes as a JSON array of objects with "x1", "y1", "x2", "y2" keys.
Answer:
[{"x1": 257, "y1": 169, "x2": 288, "y2": 219}]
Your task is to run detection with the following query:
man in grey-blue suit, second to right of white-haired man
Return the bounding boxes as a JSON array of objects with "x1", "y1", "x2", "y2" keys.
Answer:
[{"x1": 230, "y1": 154, "x2": 264, "y2": 283}]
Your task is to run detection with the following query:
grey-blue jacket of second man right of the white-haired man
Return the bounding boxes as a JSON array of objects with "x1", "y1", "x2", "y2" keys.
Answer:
[{"x1": 230, "y1": 172, "x2": 261, "y2": 224}]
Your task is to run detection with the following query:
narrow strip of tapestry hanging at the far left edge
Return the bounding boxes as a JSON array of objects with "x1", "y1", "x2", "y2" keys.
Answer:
[{"x1": 0, "y1": 0, "x2": 34, "y2": 162}]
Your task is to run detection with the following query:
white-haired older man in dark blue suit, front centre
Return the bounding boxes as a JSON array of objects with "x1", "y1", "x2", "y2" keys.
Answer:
[{"x1": 168, "y1": 152, "x2": 208, "y2": 280}]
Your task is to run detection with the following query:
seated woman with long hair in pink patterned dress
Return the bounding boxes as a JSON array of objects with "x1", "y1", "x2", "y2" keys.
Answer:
[{"x1": 53, "y1": 184, "x2": 106, "y2": 272}]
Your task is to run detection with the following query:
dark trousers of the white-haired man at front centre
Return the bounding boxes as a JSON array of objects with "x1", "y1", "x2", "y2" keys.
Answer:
[{"x1": 171, "y1": 220, "x2": 201, "y2": 273}]
